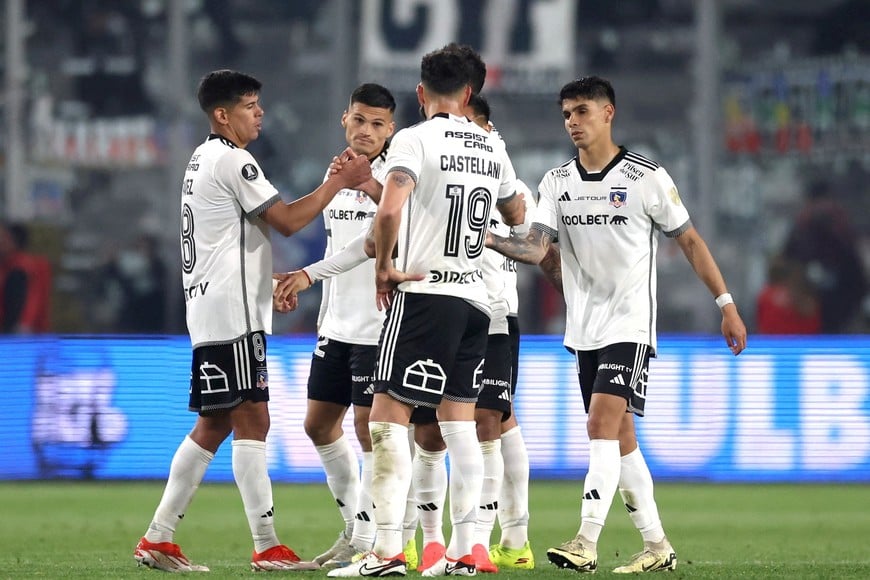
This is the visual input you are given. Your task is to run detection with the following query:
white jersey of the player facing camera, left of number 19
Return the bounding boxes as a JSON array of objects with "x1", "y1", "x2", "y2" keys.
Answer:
[{"x1": 317, "y1": 153, "x2": 386, "y2": 345}]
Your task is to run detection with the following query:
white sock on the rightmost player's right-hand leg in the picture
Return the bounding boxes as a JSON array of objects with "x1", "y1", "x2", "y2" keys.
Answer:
[{"x1": 619, "y1": 447, "x2": 665, "y2": 543}]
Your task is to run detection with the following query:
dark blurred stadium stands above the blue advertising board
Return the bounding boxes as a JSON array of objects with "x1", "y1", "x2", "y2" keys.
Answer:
[{"x1": 0, "y1": 0, "x2": 870, "y2": 333}]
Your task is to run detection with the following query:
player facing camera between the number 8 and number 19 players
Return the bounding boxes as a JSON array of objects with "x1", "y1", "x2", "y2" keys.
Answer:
[{"x1": 296, "y1": 83, "x2": 396, "y2": 569}]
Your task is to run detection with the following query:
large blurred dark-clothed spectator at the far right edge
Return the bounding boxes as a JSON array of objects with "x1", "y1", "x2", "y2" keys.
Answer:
[{"x1": 784, "y1": 181, "x2": 867, "y2": 334}]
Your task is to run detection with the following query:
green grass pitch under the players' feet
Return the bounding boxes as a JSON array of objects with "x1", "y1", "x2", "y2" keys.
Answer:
[{"x1": 0, "y1": 481, "x2": 870, "y2": 580}]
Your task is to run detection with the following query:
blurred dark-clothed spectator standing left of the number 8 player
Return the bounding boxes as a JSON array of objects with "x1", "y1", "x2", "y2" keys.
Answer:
[{"x1": 101, "y1": 235, "x2": 167, "y2": 334}]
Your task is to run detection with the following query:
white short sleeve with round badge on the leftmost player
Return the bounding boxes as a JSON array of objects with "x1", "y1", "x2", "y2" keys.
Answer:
[{"x1": 215, "y1": 149, "x2": 281, "y2": 216}]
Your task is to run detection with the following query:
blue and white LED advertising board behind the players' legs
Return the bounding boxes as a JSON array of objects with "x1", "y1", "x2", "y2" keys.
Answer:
[{"x1": 0, "y1": 336, "x2": 870, "y2": 482}]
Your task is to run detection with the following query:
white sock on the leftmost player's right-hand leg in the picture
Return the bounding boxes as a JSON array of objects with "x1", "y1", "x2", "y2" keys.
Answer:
[{"x1": 233, "y1": 439, "x2": 280, "y2": 553}]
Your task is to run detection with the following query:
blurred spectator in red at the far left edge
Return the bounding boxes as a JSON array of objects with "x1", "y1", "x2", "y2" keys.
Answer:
[{"x1": 0, "y1": 224, "x2": 51, "y2": 334}]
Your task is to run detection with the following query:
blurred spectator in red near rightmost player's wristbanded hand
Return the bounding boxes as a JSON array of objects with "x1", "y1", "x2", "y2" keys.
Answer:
[{"x1": 756, "y1": 256, "x2": 822, "y2": 334}]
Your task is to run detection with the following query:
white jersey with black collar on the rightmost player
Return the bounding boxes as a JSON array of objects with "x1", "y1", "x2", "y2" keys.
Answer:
[{"x1": 532, "y1": 148, "x2": 691, "y2": 352}]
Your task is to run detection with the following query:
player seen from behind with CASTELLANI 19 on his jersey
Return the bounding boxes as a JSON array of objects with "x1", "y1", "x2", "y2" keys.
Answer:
[{"x1": 329, "y1": 48, "x2": 523, "y2": 577}]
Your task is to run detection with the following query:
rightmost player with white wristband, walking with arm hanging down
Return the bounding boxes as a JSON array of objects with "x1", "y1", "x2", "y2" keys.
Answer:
[{"x1": 487, "y1": 77, "x2": 746, "y2": 573}]
